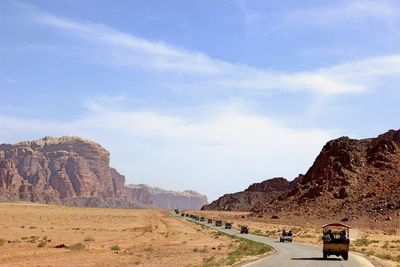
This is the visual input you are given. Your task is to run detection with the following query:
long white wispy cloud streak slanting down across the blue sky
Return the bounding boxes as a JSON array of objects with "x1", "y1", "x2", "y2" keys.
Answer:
[{"x1": 29, "y1": 13, "x2": 376, "y2": 95}]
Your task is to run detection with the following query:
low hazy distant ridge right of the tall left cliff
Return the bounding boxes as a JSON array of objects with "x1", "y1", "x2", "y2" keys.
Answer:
[{"x1": 127, "y1": 184, "x2": 208, "y2": 210}]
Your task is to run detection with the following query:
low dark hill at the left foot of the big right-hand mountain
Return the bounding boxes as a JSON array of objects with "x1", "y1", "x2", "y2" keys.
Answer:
[{"x1": 202, "y1": 175, "x2": 302, "y2": 211}]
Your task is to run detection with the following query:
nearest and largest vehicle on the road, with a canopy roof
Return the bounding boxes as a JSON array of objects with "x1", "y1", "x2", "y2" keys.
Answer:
[{"x1": 322, "y1": 223, "x2": 350, "y2": 261}]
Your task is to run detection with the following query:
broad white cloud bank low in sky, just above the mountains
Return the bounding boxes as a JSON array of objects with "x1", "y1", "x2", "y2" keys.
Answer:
[{"x1": 0, "y1": 102, "x2": 334, "y2": 201}]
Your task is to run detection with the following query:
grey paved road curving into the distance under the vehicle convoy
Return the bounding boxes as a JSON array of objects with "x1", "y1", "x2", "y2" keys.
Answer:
[{"x1": 178, "y1": 217, "x2": 373, "y2": 267}]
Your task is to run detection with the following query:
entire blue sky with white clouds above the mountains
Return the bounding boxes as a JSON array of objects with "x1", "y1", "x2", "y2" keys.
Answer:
[{"x1": 0, "y1": 0, "x2": 400, "y2": 201}]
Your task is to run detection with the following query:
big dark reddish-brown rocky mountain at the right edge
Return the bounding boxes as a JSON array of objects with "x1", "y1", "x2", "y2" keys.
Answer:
[{"x1": 206, "y1": 130, "x2": 400, "y2": 223}]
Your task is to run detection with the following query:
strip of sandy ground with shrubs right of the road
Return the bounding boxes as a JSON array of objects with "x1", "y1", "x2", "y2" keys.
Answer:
[{"x1": 188, "y1": 211, "x2": 400, "y2": 267}]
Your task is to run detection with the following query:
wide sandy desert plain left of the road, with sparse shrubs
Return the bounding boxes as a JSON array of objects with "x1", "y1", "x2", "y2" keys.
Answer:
[{"x1": 0, "y1": 203, "x2": 262, "y2": 266}]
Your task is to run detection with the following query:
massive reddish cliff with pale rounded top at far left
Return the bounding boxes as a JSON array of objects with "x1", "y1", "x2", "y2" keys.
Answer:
[{"x1": 0, "y1": 137, "x2": 125, "y2": 206}]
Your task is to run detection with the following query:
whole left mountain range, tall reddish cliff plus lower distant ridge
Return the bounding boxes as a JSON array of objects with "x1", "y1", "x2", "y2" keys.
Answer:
[{"x1": 0, "y1": 137, "x2": 207, "y2": 209}]
